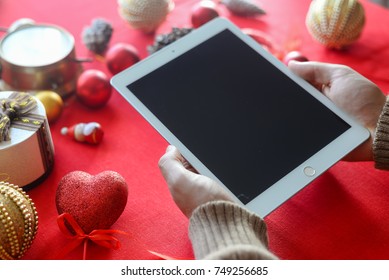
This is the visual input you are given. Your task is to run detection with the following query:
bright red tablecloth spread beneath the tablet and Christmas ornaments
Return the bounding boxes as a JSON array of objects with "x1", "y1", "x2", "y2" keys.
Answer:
[{"x1": 0, "y1": 0, "x2": 389, "y2": 259}]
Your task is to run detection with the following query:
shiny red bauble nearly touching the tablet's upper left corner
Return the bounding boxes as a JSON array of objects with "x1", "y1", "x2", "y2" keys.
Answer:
[{"x1": 105, "y1": 43, "x2": 140, "y2": 75}]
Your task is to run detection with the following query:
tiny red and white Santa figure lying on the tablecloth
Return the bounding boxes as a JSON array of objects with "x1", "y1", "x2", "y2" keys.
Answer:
[{"x1": 61, "y1": 122, "x2": 104, "y2": 144}]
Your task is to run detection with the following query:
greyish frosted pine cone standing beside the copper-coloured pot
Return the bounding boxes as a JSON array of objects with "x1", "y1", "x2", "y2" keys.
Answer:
[{"x1": 82, "y1": 19, "x2": 113, "y2": 54}]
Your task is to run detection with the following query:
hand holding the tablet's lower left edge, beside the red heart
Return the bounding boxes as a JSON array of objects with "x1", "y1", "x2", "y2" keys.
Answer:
[{"x1": 158, "y1": 146, "x2": 233, "y2": 218}]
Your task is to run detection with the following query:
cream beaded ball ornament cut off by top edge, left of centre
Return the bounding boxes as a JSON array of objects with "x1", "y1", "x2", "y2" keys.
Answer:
[{"x1": 118, "y1": 0, "x2": 174, "y2": 33}]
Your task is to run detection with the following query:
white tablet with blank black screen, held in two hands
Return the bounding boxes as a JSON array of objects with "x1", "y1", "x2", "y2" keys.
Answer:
[{"x1": 111, "y1": 18, "x2": 369, "y2": 217}]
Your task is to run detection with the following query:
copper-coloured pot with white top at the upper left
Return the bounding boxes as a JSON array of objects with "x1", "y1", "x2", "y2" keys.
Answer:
[{"x1": 0, "y1": 24, "x2": 85, "y2": 97}]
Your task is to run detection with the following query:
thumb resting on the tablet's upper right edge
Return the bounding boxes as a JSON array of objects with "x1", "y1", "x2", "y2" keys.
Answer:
[{"x1": 288, "y1": 61, "x2": 335, "y2": 86}]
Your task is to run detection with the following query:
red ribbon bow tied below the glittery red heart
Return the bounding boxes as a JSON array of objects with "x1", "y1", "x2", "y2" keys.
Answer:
[{"x1": 57, "y1": 213, "x2": 128, "y2": 260}]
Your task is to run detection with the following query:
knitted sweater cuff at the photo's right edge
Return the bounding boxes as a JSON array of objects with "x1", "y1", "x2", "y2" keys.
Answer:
[{"x1": 373, "y1": 97, "x2": 389, "y2": 170}]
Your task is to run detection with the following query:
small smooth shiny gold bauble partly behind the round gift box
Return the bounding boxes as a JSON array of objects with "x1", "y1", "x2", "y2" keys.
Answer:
[{"x1": 35, "y1": 90, "x2": 63, "y2": 123}]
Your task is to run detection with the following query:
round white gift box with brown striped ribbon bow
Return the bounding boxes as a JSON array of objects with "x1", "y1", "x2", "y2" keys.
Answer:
[{"x1": 0, "y1": 91, "x2": 54, "y2": 190}]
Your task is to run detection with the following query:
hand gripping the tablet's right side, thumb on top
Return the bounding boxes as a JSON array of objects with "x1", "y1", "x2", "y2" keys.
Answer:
[{"x1": 288, "y1": 61, "x2": 386, "y2": 161}]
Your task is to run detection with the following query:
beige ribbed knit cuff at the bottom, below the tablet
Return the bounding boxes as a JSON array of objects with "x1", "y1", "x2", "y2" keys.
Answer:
[{"x1": 189, "y1": 201, "x2": 275, "y2": 259}]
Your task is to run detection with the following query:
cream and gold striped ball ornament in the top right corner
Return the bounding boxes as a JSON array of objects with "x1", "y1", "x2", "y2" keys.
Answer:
[{"x1": 306, "y1": 0, "x2": 365, "y2": 49}]
